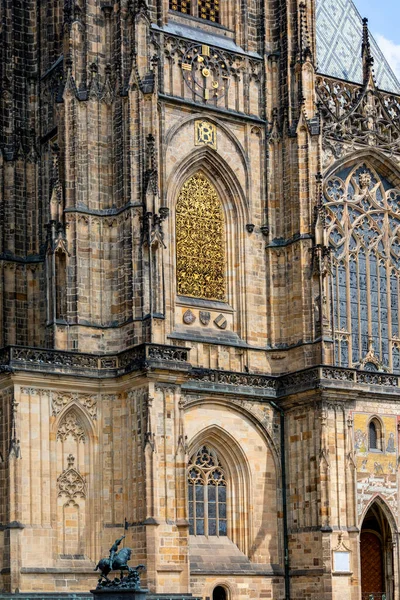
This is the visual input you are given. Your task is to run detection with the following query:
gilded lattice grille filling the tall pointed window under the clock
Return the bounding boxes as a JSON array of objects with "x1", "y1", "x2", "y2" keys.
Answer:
[{"x1": 176, "y1": 173, "x2": 226, "y2": 300}]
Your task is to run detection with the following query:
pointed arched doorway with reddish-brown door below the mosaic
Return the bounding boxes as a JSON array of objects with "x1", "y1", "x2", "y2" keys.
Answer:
[{"x1": 360, "y1": 502, "x2": 394, "y2": 600}]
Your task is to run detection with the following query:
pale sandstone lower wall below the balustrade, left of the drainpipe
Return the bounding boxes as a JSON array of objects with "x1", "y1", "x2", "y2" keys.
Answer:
[{"x1": 1, "y1": 377, "x2": 283, "y2": 594}]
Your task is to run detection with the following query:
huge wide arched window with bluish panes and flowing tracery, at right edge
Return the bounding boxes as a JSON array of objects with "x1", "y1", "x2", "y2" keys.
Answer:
[{"x1": 325, "y1": 163, "x2": 400, "y2": 372}]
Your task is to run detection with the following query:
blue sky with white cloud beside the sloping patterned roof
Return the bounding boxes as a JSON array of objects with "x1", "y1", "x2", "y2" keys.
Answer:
[{"x1": 353, "y1": 0, "x2": 400, "y2": 81}]
